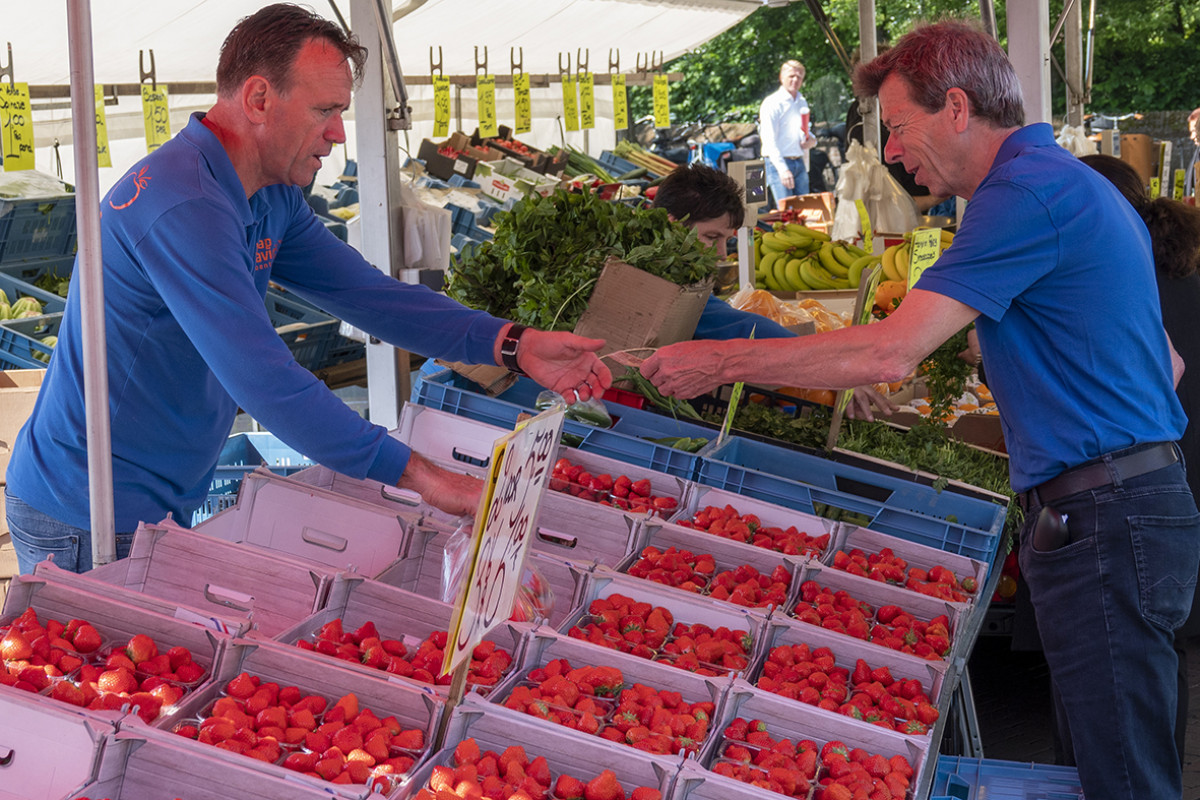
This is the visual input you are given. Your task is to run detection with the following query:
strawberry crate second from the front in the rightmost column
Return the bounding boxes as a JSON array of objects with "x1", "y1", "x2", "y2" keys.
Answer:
[{"x1": 746, "y1": 615, "x2": 952, "y2": 735}]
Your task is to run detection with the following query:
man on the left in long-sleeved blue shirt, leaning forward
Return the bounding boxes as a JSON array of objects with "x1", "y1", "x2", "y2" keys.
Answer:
[{"x1": 6, "y1": 4, "x2": 611, "y2": 573}]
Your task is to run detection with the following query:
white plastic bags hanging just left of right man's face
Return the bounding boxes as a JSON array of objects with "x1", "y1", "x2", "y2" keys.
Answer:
[{"x1": 830, "y1": 140, "x2": 920, "y2": 242}]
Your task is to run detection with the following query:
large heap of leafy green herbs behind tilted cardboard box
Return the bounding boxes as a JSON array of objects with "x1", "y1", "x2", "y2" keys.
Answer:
[{"x1": 446, "y1": 190, "x2": 716, "y2": 330}]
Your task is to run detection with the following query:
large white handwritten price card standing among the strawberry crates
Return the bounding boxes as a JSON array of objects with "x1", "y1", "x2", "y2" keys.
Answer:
[{"x1": 442, "y1": 405, "x2": 565, "y2": 674}]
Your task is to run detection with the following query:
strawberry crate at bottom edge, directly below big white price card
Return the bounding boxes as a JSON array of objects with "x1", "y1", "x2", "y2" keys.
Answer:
[{"x1": 392, "y1": 697, "x2": 682, "y2": 800}]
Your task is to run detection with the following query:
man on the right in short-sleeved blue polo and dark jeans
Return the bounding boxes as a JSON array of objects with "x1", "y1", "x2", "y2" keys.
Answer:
[{"x1": 642, "y1": 22, "x2": 1200, "y2": 800}]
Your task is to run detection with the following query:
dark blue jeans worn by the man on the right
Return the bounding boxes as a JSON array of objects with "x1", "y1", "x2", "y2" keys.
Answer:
[{"x1": 1019, "y1": 450, "x2": 1200, "y2": 800}]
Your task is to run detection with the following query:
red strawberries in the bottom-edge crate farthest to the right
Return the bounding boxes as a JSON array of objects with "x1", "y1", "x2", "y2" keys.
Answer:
[{"x1": 712, "y1": 717, "x2": 913, "y2": 800}]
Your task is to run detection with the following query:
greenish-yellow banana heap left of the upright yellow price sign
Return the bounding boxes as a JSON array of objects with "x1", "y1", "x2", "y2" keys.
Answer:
[{"x1": 754, "y1": 222, "x2": 880, "y2": 291}]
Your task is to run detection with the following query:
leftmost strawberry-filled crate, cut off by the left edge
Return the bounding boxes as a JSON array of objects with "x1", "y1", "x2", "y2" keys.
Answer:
[{"x1": 0, "y1": 576, "x2": 229, "y2": 722}]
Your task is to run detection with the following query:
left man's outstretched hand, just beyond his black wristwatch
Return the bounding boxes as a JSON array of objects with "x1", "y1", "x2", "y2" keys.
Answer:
[{"x1": 517, "y1": 329, "x2": 612, "y2": 403}]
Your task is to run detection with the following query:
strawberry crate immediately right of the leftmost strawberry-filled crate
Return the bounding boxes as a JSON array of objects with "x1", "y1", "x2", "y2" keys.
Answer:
[{"x1": 157, "y1": 639, "x2": 445, "y2": 798}]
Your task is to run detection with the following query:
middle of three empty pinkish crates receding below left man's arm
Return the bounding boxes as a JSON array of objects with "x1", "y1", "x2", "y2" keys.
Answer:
[{"x1": 196, "y1": 468, "x2": 419, "y2": 575}]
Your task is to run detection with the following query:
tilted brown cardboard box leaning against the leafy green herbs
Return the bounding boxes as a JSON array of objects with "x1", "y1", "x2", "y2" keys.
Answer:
[{"x1": 575, "y1": 258, "x2": 713, "y2": 372}]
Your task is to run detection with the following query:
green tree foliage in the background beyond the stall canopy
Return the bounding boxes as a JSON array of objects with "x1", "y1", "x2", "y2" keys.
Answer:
[{"x1": 630, "y1": 0, "x2": 1200, "y2": 124}]
